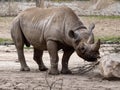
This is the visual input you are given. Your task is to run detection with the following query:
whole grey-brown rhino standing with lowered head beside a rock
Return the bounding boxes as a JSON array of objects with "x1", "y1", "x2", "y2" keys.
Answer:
[{"x1": 11, "y1": 7, "x2": 100, "y2": 75}]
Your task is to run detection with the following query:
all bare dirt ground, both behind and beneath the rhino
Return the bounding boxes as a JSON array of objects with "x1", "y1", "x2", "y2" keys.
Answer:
[{"x1": 0, "y1": 17, "x2": 120, "y2": 90}]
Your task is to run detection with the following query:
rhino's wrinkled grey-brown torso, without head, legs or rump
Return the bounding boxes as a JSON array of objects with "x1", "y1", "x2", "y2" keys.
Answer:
[{"x1": 19, "y1": 7, "x2": 82, "y2": 48}]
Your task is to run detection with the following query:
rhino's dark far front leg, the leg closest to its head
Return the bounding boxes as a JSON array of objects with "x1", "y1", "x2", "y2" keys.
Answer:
[{"x1": 61, "y1": 49, "x2": 74, "y2": 74}]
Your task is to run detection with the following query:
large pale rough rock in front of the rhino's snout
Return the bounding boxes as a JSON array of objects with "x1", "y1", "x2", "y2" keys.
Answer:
[{"x1": 99, "y1": 53, "x2": 120, "y2": 78}]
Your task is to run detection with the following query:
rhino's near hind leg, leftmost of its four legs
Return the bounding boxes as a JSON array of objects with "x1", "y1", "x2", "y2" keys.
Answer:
[{"x1": 11, "y1": 25, "x2": 30, "y2": 71}]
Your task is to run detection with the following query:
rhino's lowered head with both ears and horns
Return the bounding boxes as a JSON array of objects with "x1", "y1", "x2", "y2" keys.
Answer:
[{"x1": 69, "y1": 24, "x2": 100, "y2": 62}]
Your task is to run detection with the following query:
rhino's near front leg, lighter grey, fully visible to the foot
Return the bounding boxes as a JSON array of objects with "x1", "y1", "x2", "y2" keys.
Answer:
[{"x1": 47, "y1": 41, "x2": 59, "y2": 75}]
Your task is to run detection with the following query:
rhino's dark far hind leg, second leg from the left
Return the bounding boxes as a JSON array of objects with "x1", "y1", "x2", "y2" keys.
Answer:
[{"x1": 33, "y1": 48, "x2": 48, "y2": 71}]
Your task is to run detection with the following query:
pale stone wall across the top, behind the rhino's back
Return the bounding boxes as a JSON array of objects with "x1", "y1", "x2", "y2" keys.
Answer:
[{"x1": 0, "y1": 0, "x2": 120, "y2": 16}]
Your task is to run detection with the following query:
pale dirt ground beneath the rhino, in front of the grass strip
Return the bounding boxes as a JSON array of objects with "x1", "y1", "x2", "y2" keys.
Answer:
[{"x1": 0, "y1": 46, "x2": 120, "y2": 90}]
